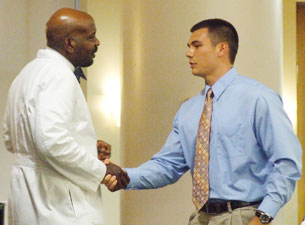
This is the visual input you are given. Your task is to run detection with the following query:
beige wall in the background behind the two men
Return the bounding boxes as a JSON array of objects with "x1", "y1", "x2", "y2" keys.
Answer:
[{"x1": 0, "y1": 0, "x2": 297, "y2": 225}]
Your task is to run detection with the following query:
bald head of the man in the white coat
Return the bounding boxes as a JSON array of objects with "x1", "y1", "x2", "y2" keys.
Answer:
[{"x1": 46, "y1": 8, "x2": 99, "y2": 67}]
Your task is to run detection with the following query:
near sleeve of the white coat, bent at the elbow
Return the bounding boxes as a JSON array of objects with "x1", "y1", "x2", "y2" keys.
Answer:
[{"x1": 32, "y1": 68, "x2": 106, "y2": 191}]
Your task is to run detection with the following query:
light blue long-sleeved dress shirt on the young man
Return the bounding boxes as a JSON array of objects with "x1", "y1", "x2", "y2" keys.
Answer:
[{"x1": 126, "y1": 68, "x2": 302, "y2": 217}]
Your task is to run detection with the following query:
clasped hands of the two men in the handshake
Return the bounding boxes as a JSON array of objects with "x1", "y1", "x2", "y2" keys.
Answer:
[{"x1": 102, "y1": 160, "x2": 130, "y2": 192}]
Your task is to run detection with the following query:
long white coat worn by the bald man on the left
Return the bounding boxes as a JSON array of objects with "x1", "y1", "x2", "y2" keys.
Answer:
[{"x1": 4, "y1": 49, "x2": 106, "y2": 225}]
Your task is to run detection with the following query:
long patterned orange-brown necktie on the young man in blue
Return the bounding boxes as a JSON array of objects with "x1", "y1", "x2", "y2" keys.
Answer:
[{"x1": 193, "y1": 88, "x2": 214, "y2": 211}]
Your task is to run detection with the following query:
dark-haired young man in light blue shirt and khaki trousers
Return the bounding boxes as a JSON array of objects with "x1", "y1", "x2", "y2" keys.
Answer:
[{"x1": 108, "y1": 19, "x2": 302, "y2": 225}]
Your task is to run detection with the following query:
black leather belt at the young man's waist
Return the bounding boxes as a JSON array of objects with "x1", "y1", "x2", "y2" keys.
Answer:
[{"x1": 200, "y1": 201, "x2": 262, "y2": 214}]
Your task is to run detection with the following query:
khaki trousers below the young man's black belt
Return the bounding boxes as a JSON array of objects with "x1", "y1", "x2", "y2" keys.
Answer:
[{"x1": 189, "y1": 205, "x2": 268, "y2": 225}]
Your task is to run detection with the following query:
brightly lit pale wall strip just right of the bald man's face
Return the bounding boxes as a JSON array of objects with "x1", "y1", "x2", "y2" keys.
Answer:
[{"x1": 87, "y1": 0, "x2": 124, "y2": 225}]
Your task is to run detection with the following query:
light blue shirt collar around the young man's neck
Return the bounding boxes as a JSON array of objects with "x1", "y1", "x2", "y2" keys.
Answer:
[{"x1": 204, "y1": 67, "x2": 238, "y2": 101}]
